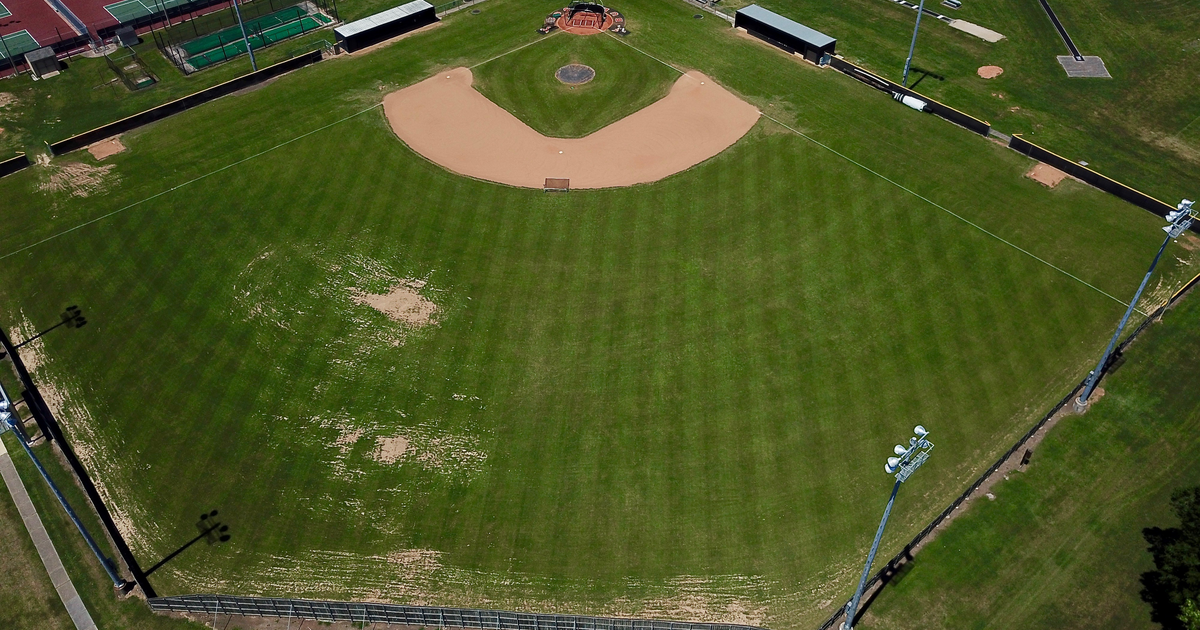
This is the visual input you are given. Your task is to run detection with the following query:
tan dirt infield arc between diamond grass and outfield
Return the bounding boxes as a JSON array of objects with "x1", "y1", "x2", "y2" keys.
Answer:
[{"x1": 383, "y1": 67, "x2": 758, "y2": 188}]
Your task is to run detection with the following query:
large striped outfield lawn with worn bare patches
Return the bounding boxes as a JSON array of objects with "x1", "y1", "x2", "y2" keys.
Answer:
[{"x1": 0, "y1": 0, "x2": 1196, "y2": 628}]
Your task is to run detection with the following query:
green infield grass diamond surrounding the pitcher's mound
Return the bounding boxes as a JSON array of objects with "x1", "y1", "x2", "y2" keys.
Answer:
[{"x1": 472, "y1": 32, "x2": 679, "y2": 138}]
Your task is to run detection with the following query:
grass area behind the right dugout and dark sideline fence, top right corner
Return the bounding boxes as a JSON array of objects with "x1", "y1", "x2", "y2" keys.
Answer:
[{"x1": 721, "y1": 0, "x2": 1200, "y2": 205}]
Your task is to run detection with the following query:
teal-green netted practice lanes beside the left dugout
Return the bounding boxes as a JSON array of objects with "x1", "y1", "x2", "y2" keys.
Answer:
[{"x1": 180, "y1": 6, "x2": 334, "y2": 70}]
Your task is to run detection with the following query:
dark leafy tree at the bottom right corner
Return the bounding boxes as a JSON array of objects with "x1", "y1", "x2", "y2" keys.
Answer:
[{"x1": 1141, "y1": 486, "x2": 1200, "y2": 630}]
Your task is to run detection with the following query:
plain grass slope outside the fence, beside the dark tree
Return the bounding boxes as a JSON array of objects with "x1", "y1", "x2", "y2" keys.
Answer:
[{"x1": 860, "y1": 290, "x2": 1200, "y2": 629}]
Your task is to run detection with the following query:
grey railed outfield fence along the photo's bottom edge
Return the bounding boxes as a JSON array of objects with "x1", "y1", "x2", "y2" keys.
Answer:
[{"x1": 148, "y1": 595, "x2": 763, "y2": 630}]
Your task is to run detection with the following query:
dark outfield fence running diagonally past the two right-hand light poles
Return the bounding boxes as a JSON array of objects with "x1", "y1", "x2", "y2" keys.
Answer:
[{"x1": 818, "y1": 274, "x2": 1200, "y2": 630}]
